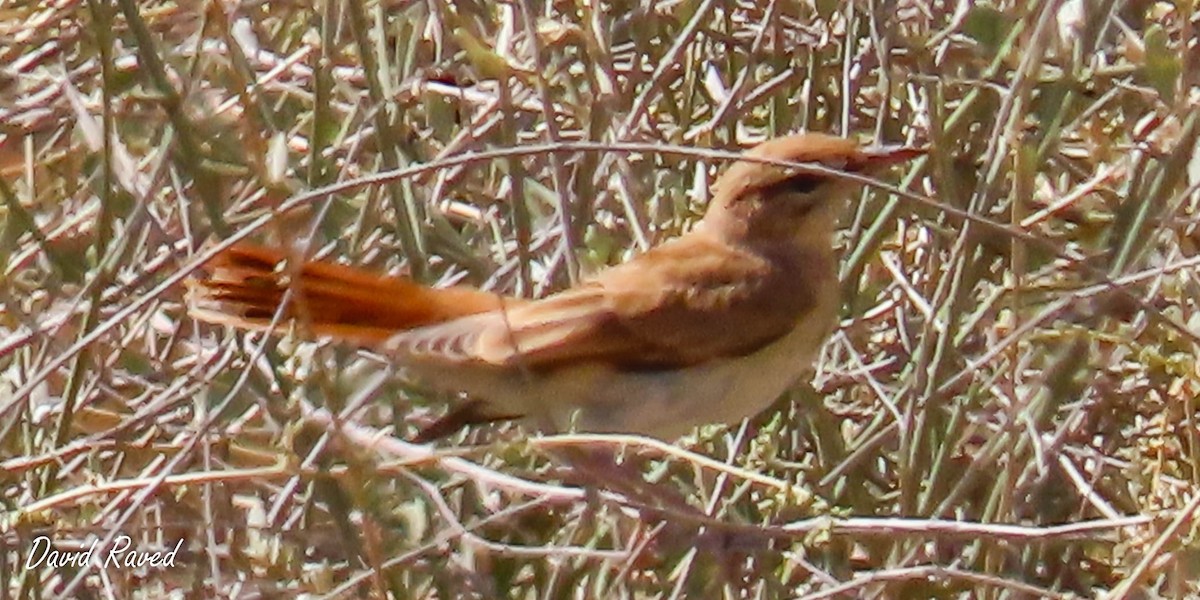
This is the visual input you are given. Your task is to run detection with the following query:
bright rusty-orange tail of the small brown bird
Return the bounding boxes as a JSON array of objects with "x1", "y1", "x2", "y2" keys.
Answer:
[{"x1": 187, "y1": 245, "x2": 521, "y2": 344}]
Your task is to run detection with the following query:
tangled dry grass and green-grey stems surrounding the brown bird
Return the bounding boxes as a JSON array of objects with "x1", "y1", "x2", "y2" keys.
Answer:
[{"x1": 0, "y1": 0, "x2": 1200, "y2": 598}]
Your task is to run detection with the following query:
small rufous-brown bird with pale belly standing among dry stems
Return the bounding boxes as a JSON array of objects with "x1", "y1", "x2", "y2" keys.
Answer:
[{"x1": 187, "y1": 133, "x2": 925, "y2": 442}]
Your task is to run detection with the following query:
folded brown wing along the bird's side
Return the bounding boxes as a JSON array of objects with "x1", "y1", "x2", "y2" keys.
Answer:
[{"x1": 391, "y1": 233, "x2": 833, "y2": 371}]
